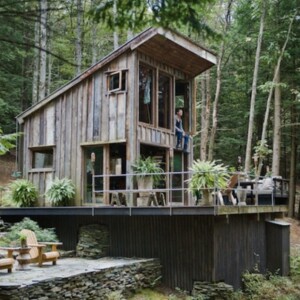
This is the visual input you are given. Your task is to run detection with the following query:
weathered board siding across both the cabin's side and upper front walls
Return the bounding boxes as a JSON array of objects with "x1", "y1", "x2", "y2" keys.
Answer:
[{"x1": 23, "y1": 52, "x2": 197, "y2": 205}]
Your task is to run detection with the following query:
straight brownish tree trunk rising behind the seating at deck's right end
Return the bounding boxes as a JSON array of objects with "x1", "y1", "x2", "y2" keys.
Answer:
[{"x1": 272, "y1": 71, "x2": 281, "y2": 176}]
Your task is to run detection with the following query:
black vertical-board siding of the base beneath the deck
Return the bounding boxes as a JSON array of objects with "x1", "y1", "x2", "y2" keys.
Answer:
[{"x1": 5, "y1": 215, "x2": 274, "y2": 290}]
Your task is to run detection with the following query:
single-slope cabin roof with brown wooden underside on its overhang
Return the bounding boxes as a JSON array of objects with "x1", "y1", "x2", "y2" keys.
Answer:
[{"x1": 17, "y1": 28, "x2": 216, "y2": 123}]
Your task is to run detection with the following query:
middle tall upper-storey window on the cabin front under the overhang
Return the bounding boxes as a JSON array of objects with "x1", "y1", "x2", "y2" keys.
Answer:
[{"x1": 158, "y1": 74, "x2": 171, "y2": 129}]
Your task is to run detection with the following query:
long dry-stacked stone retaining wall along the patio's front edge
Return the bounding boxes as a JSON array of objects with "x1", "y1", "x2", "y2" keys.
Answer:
[{"x1": 0, "y1": 259, "x2": 161, "y2": 300}]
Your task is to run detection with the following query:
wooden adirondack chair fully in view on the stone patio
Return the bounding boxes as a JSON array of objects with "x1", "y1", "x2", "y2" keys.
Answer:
[{"x1": 21, "y1": 229, "x2": 62, "y2": 267}]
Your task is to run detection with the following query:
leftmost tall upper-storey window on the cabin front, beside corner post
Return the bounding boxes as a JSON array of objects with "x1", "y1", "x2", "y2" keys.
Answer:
[{"x1": 139, "y1": 65, "x2": 154, "y2": 124}]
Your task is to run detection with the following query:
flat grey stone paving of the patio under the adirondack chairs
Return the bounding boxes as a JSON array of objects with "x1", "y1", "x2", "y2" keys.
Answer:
[{"x1": 0, "y1": 257, "x2": 151, "y2": 288}]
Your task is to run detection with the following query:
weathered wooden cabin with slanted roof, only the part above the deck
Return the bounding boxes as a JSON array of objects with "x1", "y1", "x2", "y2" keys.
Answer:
[{"x1": 17, "y1": 28, "x2": 216, "y2": 206}]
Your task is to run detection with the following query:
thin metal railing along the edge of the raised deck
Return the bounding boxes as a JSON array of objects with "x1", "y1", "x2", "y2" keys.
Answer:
[{"x1": 91, "y1": 171, "x2": 288, "y2": 206}]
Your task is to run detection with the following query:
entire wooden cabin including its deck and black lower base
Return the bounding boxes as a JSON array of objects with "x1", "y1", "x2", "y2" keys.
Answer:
[{"x1": 11, "y1": 28, "x2": 289, "y2": 291}]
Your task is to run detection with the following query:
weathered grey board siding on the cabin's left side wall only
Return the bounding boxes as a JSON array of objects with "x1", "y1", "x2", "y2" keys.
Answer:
[{"x1": 23, "y1": 55, "x2": 128, "y2": 204}]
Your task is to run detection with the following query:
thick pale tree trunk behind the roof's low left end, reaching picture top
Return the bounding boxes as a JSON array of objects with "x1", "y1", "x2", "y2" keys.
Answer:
[{"x1": 39, "y1": 0, "x2": 48, "y2": 100}]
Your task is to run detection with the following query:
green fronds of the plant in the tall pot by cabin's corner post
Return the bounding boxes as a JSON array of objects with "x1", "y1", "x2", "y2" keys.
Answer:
[{"x1": 131, "y1": 156, "x2": 164, "y2": 183}]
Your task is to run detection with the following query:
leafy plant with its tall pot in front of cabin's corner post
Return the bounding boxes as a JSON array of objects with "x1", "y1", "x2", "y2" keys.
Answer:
[{"x1": 131, "y1": 156, "x2": 164, "y2": 205}]
